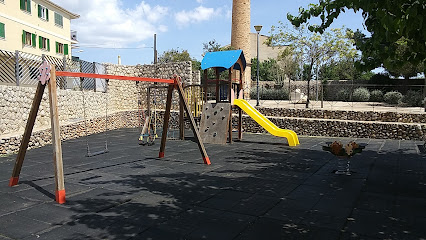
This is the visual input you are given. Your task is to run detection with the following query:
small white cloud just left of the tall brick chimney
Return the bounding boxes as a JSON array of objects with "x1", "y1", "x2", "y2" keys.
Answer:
[{"x1": 175, "y1": 6, "x2": 222, "y2": 27}]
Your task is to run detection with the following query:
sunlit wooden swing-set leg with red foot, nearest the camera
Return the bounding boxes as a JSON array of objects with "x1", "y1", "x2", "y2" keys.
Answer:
[{"x1": 48, "y1": 65, "x2": 65, "y2": 204}]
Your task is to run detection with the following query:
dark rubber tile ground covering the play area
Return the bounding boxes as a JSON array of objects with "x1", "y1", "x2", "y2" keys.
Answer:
[{"x1": 0, "y1": 129, "x2": 426, "y2": 240}]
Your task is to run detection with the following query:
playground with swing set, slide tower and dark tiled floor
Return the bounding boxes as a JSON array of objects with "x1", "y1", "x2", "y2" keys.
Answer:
[{"x1": 0, "y1": 50, "x2": 426, "y2": 239}]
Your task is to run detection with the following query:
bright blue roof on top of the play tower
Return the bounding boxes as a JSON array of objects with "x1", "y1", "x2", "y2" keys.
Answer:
[{"x1": 201, "y1": 50, "x2": 247, "y2": 71}]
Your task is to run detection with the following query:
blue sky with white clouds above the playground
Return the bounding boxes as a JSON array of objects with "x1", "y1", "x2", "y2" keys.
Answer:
[{"x1": 51, "y1": 0, "x2": 366, "y2": 65}]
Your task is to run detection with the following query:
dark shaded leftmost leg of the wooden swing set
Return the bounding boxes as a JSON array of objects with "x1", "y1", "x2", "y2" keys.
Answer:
[{"x1": 9, "y1": 82, "x2": 46, "y2": 187}]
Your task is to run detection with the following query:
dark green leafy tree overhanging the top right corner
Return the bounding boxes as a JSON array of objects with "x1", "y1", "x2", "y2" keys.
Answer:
[{"x1": 287, "y1": 0, "x2": 426, "y2": 72}]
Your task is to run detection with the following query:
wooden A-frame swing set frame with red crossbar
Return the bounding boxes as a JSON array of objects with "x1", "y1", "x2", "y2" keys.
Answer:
[{"x1": 9, "y1": 61, "x2": 211, "y2": 204}]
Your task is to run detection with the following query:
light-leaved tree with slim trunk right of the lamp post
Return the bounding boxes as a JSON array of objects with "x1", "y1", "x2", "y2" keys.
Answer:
[{"x1": 267, "y1": 22, "x2": 357, "y2": 108}]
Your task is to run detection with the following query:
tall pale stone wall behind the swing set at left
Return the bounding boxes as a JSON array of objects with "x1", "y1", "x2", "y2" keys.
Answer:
[{"x1": 0, "y1": 62, "x2": 196, "y2": 154}]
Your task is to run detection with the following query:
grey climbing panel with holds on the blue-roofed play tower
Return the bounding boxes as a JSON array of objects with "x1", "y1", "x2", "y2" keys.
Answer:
[{"x1": 200, "y1": 103, "x2": 231, "y2": 144}]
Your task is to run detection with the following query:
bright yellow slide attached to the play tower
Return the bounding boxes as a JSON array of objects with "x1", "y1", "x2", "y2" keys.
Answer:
[{"x1": 234, "y1": 99, "x2": 299, "y2": 146}]
